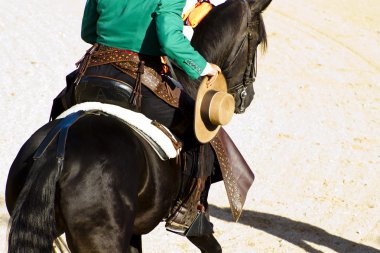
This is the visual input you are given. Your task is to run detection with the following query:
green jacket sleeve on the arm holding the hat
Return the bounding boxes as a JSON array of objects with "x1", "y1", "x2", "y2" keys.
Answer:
[{"x1": 155, "y1": 0, "x2": 207, "y2": 79}]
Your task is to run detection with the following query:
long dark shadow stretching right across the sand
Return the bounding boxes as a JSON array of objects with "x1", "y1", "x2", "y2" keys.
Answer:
[{"x1": 210, "y1": 205, "x2": 380, "y2": 253}]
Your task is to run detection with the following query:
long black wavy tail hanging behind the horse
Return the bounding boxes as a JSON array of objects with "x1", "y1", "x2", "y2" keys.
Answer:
[{"x1": 8, "y1": 150, "x2": 59, "y2": 253}]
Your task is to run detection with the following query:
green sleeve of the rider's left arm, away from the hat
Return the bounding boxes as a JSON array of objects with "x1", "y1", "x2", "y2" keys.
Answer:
[{"x1": 81, "y1": 0, "x2": 99, "y2": 44}]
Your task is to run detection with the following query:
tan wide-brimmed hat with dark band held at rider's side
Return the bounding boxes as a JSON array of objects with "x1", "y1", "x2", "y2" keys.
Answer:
[{"x1": 194, "y1": 73, "x2": 235, "y2": 143}]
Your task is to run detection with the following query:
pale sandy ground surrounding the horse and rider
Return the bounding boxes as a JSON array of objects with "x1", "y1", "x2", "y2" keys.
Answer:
[{"x1": 0, "y1": 0, "x2": 380, "y2": 253}]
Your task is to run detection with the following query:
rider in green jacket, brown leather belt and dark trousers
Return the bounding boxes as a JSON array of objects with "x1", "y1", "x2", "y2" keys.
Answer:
[{"x1": 75, "y1": 0, "x2": 221, "y2": 239}]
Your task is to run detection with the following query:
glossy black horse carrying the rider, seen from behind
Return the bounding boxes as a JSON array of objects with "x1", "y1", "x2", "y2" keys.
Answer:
[{"x1": 6, "y1": 0, "x2": 271, "y2": 253}]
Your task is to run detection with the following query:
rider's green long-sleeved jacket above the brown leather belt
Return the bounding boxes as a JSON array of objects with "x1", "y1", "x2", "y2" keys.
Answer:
[{"x1": 81, "y1": 0, "x2": 207, "y2": 79}]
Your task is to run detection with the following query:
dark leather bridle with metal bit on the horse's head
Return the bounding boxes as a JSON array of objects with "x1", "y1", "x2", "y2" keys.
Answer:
[{"x1": 228, "y1": 1, "x2": 257, "y2": 113}]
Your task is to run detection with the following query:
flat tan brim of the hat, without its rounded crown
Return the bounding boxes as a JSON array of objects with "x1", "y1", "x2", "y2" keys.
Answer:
[{"x1": 194, "y1": 73, "x2": 227, "y2": 143}]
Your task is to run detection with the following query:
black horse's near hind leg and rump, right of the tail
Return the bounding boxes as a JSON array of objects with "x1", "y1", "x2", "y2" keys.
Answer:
[{"x1": 59, "y1": 116, "x2": 146, "y2": 253}]
